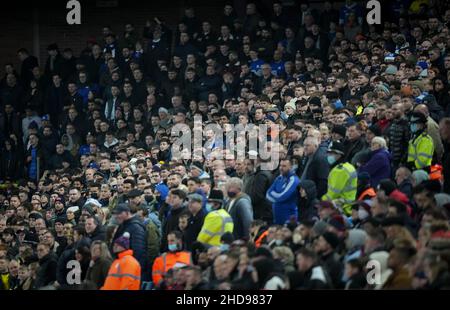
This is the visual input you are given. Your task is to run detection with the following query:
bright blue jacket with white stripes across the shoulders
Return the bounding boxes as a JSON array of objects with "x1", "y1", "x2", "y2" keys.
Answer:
[{"x1": 266, "y1": 171, "x2": 300, "y2": 225}]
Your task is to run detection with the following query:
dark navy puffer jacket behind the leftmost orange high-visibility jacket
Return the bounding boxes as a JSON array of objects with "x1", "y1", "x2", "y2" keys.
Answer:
[{"x1": 113, "y1": 216, "x2": 150, "y2": 280}]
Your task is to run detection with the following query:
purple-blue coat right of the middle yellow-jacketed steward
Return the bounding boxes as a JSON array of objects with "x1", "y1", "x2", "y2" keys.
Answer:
[{"x1": 358, "y1": 149, "x2": 391, "y2": 188}]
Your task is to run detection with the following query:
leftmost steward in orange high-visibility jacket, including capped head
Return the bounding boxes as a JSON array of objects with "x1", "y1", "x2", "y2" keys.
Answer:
[{"x1": 101, "y1": 233, "x2": 141, "y2": 291}]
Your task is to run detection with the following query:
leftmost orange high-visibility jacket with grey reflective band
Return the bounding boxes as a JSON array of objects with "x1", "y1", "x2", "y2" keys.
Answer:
[{"x1": 101, "y1": 250, "x2": 141, "y2": 290}]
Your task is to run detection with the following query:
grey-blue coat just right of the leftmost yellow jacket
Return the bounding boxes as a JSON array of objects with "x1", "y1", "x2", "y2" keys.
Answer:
[{"x1": 224, "y1": 192, "x2": 253, "y2": 240}]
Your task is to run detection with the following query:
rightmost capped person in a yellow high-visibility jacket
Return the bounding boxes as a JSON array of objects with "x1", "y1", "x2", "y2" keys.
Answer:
[{"x1": 406, "y1": 112, "x2": 434, "y2": 171}]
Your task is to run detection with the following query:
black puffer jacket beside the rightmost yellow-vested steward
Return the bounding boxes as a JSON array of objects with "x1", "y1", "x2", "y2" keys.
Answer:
[{"x1": 385, "y1": 117, "x2": 410, "y2": 167}]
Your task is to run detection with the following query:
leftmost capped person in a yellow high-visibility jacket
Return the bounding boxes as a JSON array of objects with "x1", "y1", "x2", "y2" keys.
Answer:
[{"x1": 197, "y1": 189, "x2": 234, "y2": 246}]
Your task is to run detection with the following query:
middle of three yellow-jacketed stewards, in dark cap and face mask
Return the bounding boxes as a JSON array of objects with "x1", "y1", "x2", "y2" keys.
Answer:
[{"x1": 322, "y1": 142, "x2": 358, "y2": 215}]
